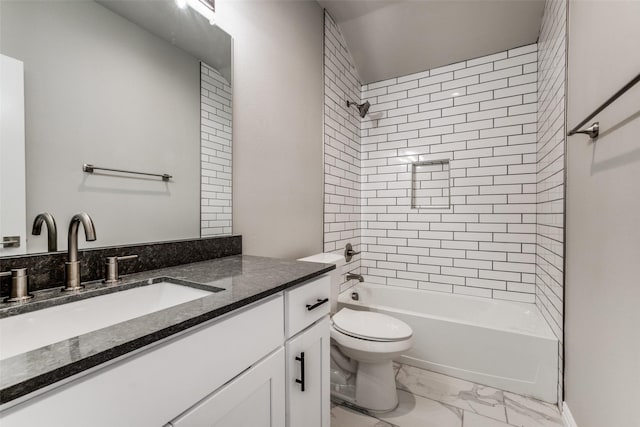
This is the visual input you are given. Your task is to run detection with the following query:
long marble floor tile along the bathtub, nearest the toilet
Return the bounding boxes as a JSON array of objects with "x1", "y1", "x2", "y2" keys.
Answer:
[{"x1": 396, "y1": 365, "x2": 507, "y2": 422}]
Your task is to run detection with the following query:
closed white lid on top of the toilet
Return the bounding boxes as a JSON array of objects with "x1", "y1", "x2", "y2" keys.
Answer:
[{"x1": 332, "y1": 308, "x2": 413, "y2": 341}]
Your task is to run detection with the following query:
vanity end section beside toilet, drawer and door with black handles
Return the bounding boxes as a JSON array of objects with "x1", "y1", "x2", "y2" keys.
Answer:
[{"x1": 285, "y1": 277, "x2": 331, "y2": 427}]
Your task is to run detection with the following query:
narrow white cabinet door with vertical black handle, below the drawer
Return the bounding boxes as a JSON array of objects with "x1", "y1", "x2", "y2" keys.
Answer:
[{"x1": 286, "y1": 317, "x2": 330, "y2": 427}]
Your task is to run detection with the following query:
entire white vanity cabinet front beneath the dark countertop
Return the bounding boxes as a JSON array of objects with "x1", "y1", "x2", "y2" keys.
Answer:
[{"x1": 0, "y1": 276, "x2": 330, "y2": 427}]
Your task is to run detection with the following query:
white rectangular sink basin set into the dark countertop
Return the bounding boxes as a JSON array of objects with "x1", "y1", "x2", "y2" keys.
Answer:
[{"x1": 0, "y1": 282, "x2": 213, "y2": 360}]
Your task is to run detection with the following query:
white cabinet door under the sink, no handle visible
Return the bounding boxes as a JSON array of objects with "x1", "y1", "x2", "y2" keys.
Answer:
[{"x1": 169, "y1": 348, "x2": 285, "y2": 427}]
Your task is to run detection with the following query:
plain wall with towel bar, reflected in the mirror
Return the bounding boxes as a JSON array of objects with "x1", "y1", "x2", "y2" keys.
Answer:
[{"x1": 0, "y1": 1, "x2": 200, "y2": 252}]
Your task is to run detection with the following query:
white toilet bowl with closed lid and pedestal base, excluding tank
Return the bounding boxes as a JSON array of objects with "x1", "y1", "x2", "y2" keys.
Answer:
[{"x1": 330, "y1": 308, "x2": 413, "y2": 412}]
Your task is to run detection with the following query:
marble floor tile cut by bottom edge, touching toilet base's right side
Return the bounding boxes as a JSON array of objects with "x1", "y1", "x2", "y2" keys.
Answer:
[{"x1": 378, "y1": 390, "x2": 462, "y2": 427}]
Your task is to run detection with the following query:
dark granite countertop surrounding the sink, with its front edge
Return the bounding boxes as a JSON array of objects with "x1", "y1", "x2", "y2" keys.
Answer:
[{"x1": 0, "y1": 255, "x2": 335, "y2": 404}]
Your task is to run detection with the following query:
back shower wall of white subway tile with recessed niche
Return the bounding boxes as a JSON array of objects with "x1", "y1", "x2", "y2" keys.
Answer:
[{"x1": 360, "y1": 44, "x2": 538, "y2": 303}]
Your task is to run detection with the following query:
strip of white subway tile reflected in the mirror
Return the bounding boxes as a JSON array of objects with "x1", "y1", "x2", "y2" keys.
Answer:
[{"x1": 200, "y1": 63, "x2": 232, "y2": 237}]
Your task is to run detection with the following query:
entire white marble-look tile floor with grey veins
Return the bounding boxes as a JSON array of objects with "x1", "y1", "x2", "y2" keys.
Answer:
[{"x1": 331, "y1": 365, "x2": 564, "y2": 427}]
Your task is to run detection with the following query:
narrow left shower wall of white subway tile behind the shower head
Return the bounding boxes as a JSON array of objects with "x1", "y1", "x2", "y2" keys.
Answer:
[{"x1": 324, "y1": 11, "x2": 360, "y2": 289}]
